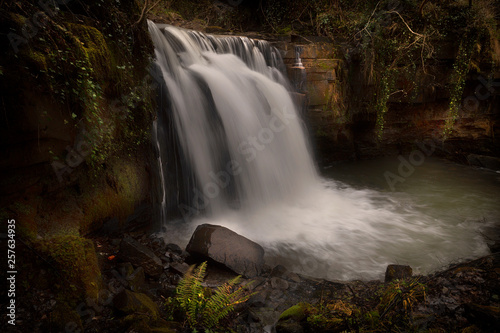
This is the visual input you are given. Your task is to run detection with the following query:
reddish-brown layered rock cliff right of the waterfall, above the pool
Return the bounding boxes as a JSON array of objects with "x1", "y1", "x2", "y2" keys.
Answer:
[{"x1": 276, "y1": 37, "x2": 500, "y2": 162}]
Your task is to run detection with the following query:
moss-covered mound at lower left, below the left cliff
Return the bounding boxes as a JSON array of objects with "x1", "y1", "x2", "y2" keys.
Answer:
[{"x1": 36, "y1": 235, "x2": 101, "y2": 302}]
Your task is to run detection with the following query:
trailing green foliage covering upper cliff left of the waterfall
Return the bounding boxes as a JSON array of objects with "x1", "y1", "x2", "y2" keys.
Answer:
[{"x1": 0, "y1": 0, "x2": 153, "y2": 179}]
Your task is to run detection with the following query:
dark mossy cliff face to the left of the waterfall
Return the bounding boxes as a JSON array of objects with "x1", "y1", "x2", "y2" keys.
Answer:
[{"x1": 0, "y1": 1, "x2": 154, "y2": 308}]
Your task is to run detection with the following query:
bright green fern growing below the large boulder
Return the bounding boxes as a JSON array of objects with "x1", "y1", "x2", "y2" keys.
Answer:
[{"x1": 175, "y1": 262, "x2": 253, "y2": 329}]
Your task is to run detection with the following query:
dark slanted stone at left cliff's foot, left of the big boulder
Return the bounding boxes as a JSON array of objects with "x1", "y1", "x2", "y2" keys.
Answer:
[{"x1": 119, "y1": 236, "x2": 163, "y2": 277}]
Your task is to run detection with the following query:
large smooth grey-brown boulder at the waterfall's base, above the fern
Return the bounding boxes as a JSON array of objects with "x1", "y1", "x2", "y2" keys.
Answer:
[{"x1": 186, "y1": 224, "x2": 264, "y2": 278}]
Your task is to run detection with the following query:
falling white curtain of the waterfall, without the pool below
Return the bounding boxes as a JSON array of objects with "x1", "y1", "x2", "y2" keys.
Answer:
[{"x1": 148, "y1": 22, "x2": 317, "y2": 222}]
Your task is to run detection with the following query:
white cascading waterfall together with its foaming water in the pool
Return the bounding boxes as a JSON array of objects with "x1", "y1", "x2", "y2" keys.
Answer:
[{"x1": 149, "y1": 22, "x2": 496, "y2": 279}]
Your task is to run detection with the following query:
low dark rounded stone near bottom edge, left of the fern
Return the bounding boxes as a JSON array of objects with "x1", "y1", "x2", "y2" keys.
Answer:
[{"x1": 113, "y1": 289, "x2": 158, "y2": 319}]
